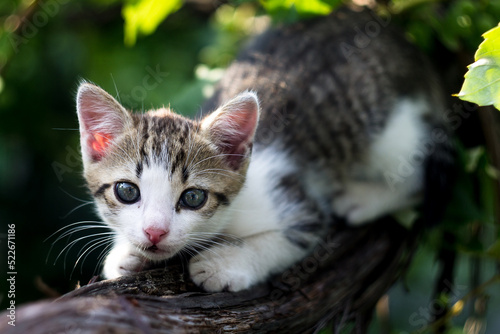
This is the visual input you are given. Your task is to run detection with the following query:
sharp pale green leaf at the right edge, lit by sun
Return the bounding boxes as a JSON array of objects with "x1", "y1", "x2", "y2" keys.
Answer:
[{"x1": 457, "y1": 25, "x2": 500, "y2": 110}]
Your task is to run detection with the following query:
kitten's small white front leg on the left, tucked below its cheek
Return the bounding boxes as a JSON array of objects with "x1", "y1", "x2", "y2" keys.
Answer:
[{"x1": 103, "y1": 242, "x2": 149, "y2": 279}]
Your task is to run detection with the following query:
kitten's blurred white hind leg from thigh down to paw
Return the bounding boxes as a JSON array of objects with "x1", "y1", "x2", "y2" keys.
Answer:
[{"x1": 333, "y1": 98, "x2": 433, "y2": 225}]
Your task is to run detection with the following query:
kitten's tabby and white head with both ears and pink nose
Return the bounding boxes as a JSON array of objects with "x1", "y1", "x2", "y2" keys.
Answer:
[{"x1": 77, "y1": 83, "x2": 259, "y2": 260}]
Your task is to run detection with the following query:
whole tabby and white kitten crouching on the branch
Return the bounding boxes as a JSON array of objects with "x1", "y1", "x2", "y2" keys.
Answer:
[{"x1": 77, "y1": 6, "x2": 451, "y2": 291}]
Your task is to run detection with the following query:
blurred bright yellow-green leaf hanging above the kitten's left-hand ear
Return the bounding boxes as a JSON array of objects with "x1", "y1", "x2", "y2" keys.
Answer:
[{"x1": 122, "y1": 0, "x2": 182, "y2": 46}]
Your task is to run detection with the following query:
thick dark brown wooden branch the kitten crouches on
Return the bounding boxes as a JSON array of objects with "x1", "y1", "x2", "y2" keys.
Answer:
[{"x1": 0, "y1": 220, "x2": 416, "y2": 334}]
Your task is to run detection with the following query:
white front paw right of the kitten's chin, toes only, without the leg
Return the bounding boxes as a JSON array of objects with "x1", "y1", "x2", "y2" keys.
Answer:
[{"x1": 189, "y1": 249, "x2": 256, "y2": 292}]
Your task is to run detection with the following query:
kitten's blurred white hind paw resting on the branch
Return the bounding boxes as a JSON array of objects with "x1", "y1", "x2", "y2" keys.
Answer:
[{"x1": 333, "y1": 183, "x2": 402, "y2": 225}]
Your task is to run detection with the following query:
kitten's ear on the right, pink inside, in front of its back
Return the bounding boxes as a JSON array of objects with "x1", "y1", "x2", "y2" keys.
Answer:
[{"x1": 201, "y1": 92, "x2": 260, "y2": 170}]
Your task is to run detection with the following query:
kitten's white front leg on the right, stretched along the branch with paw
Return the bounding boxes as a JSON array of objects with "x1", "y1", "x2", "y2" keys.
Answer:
[{"x1": 189, "y1": 232, "x2": 306, "y2": 292}]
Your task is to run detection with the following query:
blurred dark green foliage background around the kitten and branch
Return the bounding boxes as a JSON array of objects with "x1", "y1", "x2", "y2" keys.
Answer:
[{"x1": 0, "y1": 0, "x2": 500, "y2": 333}]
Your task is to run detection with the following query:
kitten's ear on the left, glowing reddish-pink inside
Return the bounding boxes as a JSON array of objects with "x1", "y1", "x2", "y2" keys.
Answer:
[{"x1": 76, "y1": 83, "x2": 132, "y2": 164}]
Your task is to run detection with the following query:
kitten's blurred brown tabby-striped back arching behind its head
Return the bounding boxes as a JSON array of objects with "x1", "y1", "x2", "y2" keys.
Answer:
[{"x1": 205, "y1": 9, "x2": 442, "y2": 164}]
